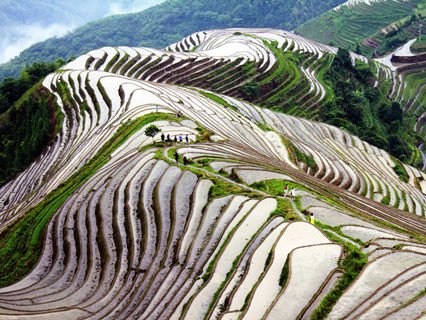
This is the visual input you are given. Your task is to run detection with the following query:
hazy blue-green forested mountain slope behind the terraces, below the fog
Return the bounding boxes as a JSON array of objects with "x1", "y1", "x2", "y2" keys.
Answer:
[{"x1": 0, "y1": 0, "x2": 343, "y2": 79}]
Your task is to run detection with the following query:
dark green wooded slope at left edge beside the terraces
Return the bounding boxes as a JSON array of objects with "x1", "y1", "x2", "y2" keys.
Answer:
[{"x1": 0, "y1": 61, "x2": 62, "y2": 186}]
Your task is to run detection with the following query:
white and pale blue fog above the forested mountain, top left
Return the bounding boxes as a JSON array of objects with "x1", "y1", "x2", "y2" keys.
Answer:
[{"x1": 0, "y1": 0, "x2": 164, "y2": 63}]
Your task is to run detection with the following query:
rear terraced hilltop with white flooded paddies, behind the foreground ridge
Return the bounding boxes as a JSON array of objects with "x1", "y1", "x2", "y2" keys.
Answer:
[{"x1": 65, "y1": 29, "x2": 342, "y2": 119}]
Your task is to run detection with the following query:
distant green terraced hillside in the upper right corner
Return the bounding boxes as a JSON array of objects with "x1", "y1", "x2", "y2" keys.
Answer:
[{"x1": 296, "y1": 0, "x2": 426, "y2": 156}]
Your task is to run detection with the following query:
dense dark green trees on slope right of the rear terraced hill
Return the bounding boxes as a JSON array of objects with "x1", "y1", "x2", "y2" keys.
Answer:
[{"x1": 320, "y1": 49, "x2": 422, "y2": 163}]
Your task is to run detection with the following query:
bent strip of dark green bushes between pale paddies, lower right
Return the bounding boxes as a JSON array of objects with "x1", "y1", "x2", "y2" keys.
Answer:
[{"x1": 311, "y1": 229, "x2": 367, "y2": 320}]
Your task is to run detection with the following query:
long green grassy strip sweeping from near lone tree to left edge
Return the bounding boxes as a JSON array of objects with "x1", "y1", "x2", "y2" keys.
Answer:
[{"x1": 0, "y1": 113, "x2": 173, "y2": 287}]
